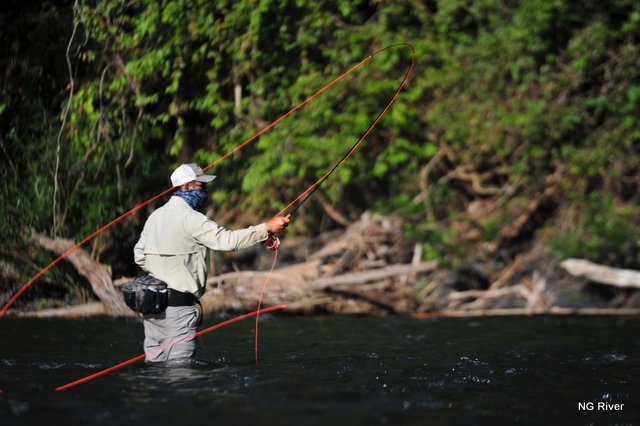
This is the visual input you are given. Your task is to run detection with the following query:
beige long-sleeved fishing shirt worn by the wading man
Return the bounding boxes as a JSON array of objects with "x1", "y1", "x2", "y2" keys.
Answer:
[{"x1": 134, "y1": 196, "x2": 269, "y2": 297}]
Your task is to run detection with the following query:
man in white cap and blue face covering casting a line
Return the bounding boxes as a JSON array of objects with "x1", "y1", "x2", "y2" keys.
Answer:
[{"x1": 134, "y1": 164, "x2": 289, "y2": 364}]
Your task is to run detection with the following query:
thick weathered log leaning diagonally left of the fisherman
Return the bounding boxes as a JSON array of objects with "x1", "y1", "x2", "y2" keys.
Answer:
[{"x1": 31, "y1": 233, "x2": 133, "y2": 316}]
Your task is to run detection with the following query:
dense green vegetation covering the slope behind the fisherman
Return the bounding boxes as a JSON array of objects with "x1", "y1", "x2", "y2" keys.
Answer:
[{"x1": 0, "y1": 0, "x2": 640, "y2": 300}]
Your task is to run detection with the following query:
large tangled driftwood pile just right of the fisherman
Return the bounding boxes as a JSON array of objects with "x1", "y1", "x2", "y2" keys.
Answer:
[{"x1": 196, "y1": 214, "x2": 437, "y2": 315}]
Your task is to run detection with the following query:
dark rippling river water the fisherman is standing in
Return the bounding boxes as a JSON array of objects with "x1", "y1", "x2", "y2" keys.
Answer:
[{"x1": 0, "y1": 315, "x2": 640, "y2": 426}]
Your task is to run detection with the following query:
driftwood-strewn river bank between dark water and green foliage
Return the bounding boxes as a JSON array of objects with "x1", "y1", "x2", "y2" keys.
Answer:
[{"x1": 9, "y1": 214, "x2": 640, "y2": 317}]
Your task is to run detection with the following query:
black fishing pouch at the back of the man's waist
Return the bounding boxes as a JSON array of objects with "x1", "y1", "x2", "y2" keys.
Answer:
[{"x1": 122, "y1": 275, "x2": 169, "y2": 314}]
